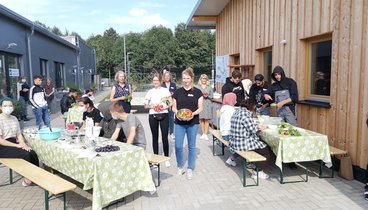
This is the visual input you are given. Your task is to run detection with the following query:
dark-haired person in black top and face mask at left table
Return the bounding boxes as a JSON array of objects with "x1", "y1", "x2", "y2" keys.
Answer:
[{"x1": 78, "y1": 97, "x2": 102, "y2": 130}]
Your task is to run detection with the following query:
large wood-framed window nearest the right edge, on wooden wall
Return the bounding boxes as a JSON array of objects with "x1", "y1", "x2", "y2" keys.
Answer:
[{"x1": 308, "y1": 40, "x2": 332, "y2": 99}]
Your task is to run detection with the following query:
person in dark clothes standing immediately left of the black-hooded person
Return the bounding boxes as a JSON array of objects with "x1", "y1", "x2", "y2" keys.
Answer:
[{"x1": 249, "y1": 74, "x2": 272, "y2": 115}]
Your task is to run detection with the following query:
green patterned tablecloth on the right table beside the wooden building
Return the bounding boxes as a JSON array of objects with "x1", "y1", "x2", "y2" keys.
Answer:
[{"x1": 260, "y1": 128, "x2": 331, "y2": 170}]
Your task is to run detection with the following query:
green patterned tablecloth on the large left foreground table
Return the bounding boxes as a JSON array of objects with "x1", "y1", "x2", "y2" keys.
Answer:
[{"x1": 24, "y1": 134, "x2": 156, "y2": 210}]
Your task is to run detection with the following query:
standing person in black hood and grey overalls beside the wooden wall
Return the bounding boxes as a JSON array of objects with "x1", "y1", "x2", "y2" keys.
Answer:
[{"x1": 264, "y1": 66, "x2": 298, "y2": 126}]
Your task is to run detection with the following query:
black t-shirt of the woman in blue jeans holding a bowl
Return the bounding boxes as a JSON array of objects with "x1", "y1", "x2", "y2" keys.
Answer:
[{"x1": 173, "y1": 87, "x2": 202, "y2": 125}]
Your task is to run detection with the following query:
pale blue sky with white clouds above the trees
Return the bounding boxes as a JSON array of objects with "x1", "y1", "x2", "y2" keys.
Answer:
[{"x1": 0, "y1": 0, "x2": 198, "y2": 39}]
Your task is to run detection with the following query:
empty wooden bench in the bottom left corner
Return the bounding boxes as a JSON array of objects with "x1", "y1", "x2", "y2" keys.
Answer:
[{"x1": 0, "y1": 158, "x2": 77, "y2": 210}]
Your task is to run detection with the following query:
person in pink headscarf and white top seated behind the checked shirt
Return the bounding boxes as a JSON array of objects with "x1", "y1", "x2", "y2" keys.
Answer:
[{"x1": 220, "y1": 93, "x2": 236, "y2": 141}]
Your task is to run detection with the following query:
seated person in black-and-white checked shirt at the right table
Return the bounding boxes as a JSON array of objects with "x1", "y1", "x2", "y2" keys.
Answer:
[{"x1": 226, "y1": 99, "x2": 270, "y2": 179}]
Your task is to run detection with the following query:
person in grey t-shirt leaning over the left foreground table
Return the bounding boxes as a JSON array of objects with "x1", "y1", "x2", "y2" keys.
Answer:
[{"x1": 110, "y1": 102, "x2": 146, "y2": 150}]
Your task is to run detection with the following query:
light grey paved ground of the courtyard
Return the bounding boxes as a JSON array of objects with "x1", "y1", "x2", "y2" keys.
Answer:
[{"x1": 0, "y1": 90, "x2": 368, "y2": 210}]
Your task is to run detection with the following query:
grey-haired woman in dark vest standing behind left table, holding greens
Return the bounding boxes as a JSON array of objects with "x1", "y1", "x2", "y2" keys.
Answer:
[{"x1": 110, "y1": 71, "x2": 132, "y2": 113}]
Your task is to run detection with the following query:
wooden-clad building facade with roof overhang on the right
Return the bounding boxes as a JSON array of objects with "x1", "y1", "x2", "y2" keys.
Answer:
[{"x1": 187, "y1": 0, "x2": 368, "y2": 173}]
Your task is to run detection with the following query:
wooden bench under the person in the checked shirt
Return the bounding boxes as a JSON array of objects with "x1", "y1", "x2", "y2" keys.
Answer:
[{"x1": 210, "y1": 130, "x2": 267, "y2": 187}]
